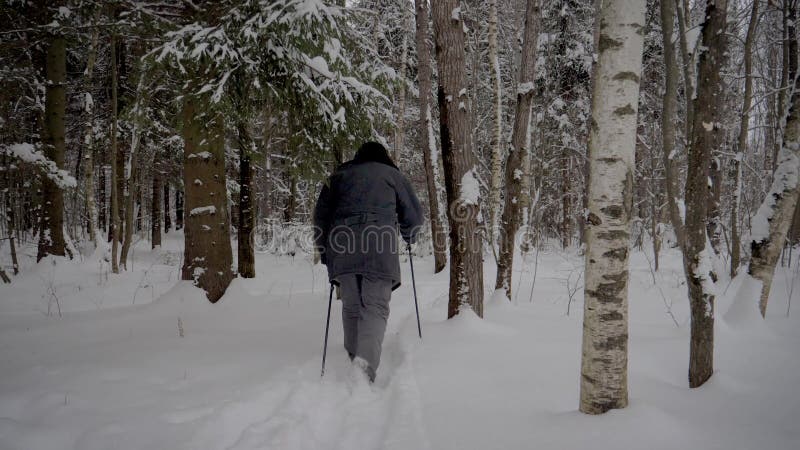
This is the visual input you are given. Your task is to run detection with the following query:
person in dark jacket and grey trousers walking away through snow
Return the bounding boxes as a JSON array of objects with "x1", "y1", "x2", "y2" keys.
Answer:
[{"x1": 314, "y1": 142, "x2": 423, "y2": 382}]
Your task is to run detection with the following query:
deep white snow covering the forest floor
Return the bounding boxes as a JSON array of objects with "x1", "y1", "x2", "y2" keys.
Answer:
[{"x1": 0, "y1": 233, "x2": 800, "y2": 450}]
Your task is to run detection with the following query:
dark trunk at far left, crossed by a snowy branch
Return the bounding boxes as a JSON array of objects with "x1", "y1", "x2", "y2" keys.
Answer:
[{"x1": 36, "y1": 31, "x2": 67, "y2": 261}]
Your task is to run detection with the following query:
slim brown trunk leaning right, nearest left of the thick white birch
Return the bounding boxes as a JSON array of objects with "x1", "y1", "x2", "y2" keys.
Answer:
[{"x1": 495, "y1": 0, "x2": 539, "y2": 299}]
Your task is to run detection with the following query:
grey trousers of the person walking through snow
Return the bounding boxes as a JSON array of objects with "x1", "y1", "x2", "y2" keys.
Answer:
[{"x1": 338, "y1": 275, "x2": 392, "y2": 378}]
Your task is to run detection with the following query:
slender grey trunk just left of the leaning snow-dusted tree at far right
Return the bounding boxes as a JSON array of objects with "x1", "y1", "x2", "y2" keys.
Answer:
[{"x1": 730, "y1": 0, "x2": 760, "y2": 277}]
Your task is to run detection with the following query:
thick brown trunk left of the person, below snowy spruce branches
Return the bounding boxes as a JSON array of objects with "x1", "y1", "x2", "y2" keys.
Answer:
[{"x1": 181, "y1": 96, "x2": 233, "y2": 303}]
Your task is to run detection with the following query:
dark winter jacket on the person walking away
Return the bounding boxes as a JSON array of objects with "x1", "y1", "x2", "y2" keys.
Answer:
[{"x1": 314, "y1": 147, "x2": 423, "y2": 289}]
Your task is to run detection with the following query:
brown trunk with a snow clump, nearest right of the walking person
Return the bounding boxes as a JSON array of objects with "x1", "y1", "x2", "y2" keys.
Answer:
[{"x1": 431, "y1": 0, "x2": 483, "y2": 318}]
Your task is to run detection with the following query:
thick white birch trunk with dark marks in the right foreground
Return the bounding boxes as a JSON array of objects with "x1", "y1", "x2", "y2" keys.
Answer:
[{"x1": 580, "y1": 0, "x2": 645, "y2": 414}]
